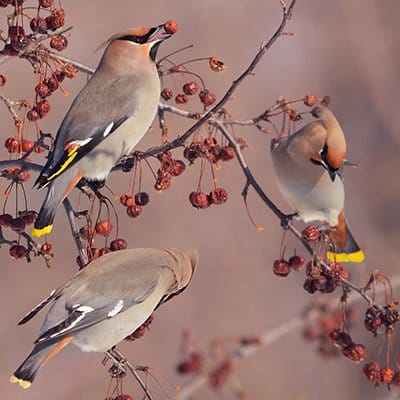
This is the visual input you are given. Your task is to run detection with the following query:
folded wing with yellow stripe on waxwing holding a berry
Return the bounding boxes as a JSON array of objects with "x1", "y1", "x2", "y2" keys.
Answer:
[{"x1": 35, "y1": 71, "x2": 141, "y2": 188}]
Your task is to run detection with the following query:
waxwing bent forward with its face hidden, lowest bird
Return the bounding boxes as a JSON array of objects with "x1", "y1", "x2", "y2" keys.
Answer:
[{"x1": 10, "y1": 248, "x2": 198, "y2": 388}]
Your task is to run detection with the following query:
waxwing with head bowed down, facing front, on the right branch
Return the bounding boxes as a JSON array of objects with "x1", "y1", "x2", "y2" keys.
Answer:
[{"x1": 271, "y1": 108, "x2": 364, "y2": 262}]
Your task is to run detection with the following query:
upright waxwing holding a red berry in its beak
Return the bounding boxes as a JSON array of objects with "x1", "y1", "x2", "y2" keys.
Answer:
[{"x1": 32, "y1": 25, "x2": 171, "y2": 236}]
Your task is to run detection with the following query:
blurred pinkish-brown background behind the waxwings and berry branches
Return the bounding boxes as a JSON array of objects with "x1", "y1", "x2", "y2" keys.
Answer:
[{"x1": 0, "y1": 0, "x2": 400, "y2": 400}]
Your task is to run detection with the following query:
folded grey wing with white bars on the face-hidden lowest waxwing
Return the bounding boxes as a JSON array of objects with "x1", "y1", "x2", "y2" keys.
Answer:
[{"x1": 35, "y1": 281, "x2": 157, "y2": 343}]
